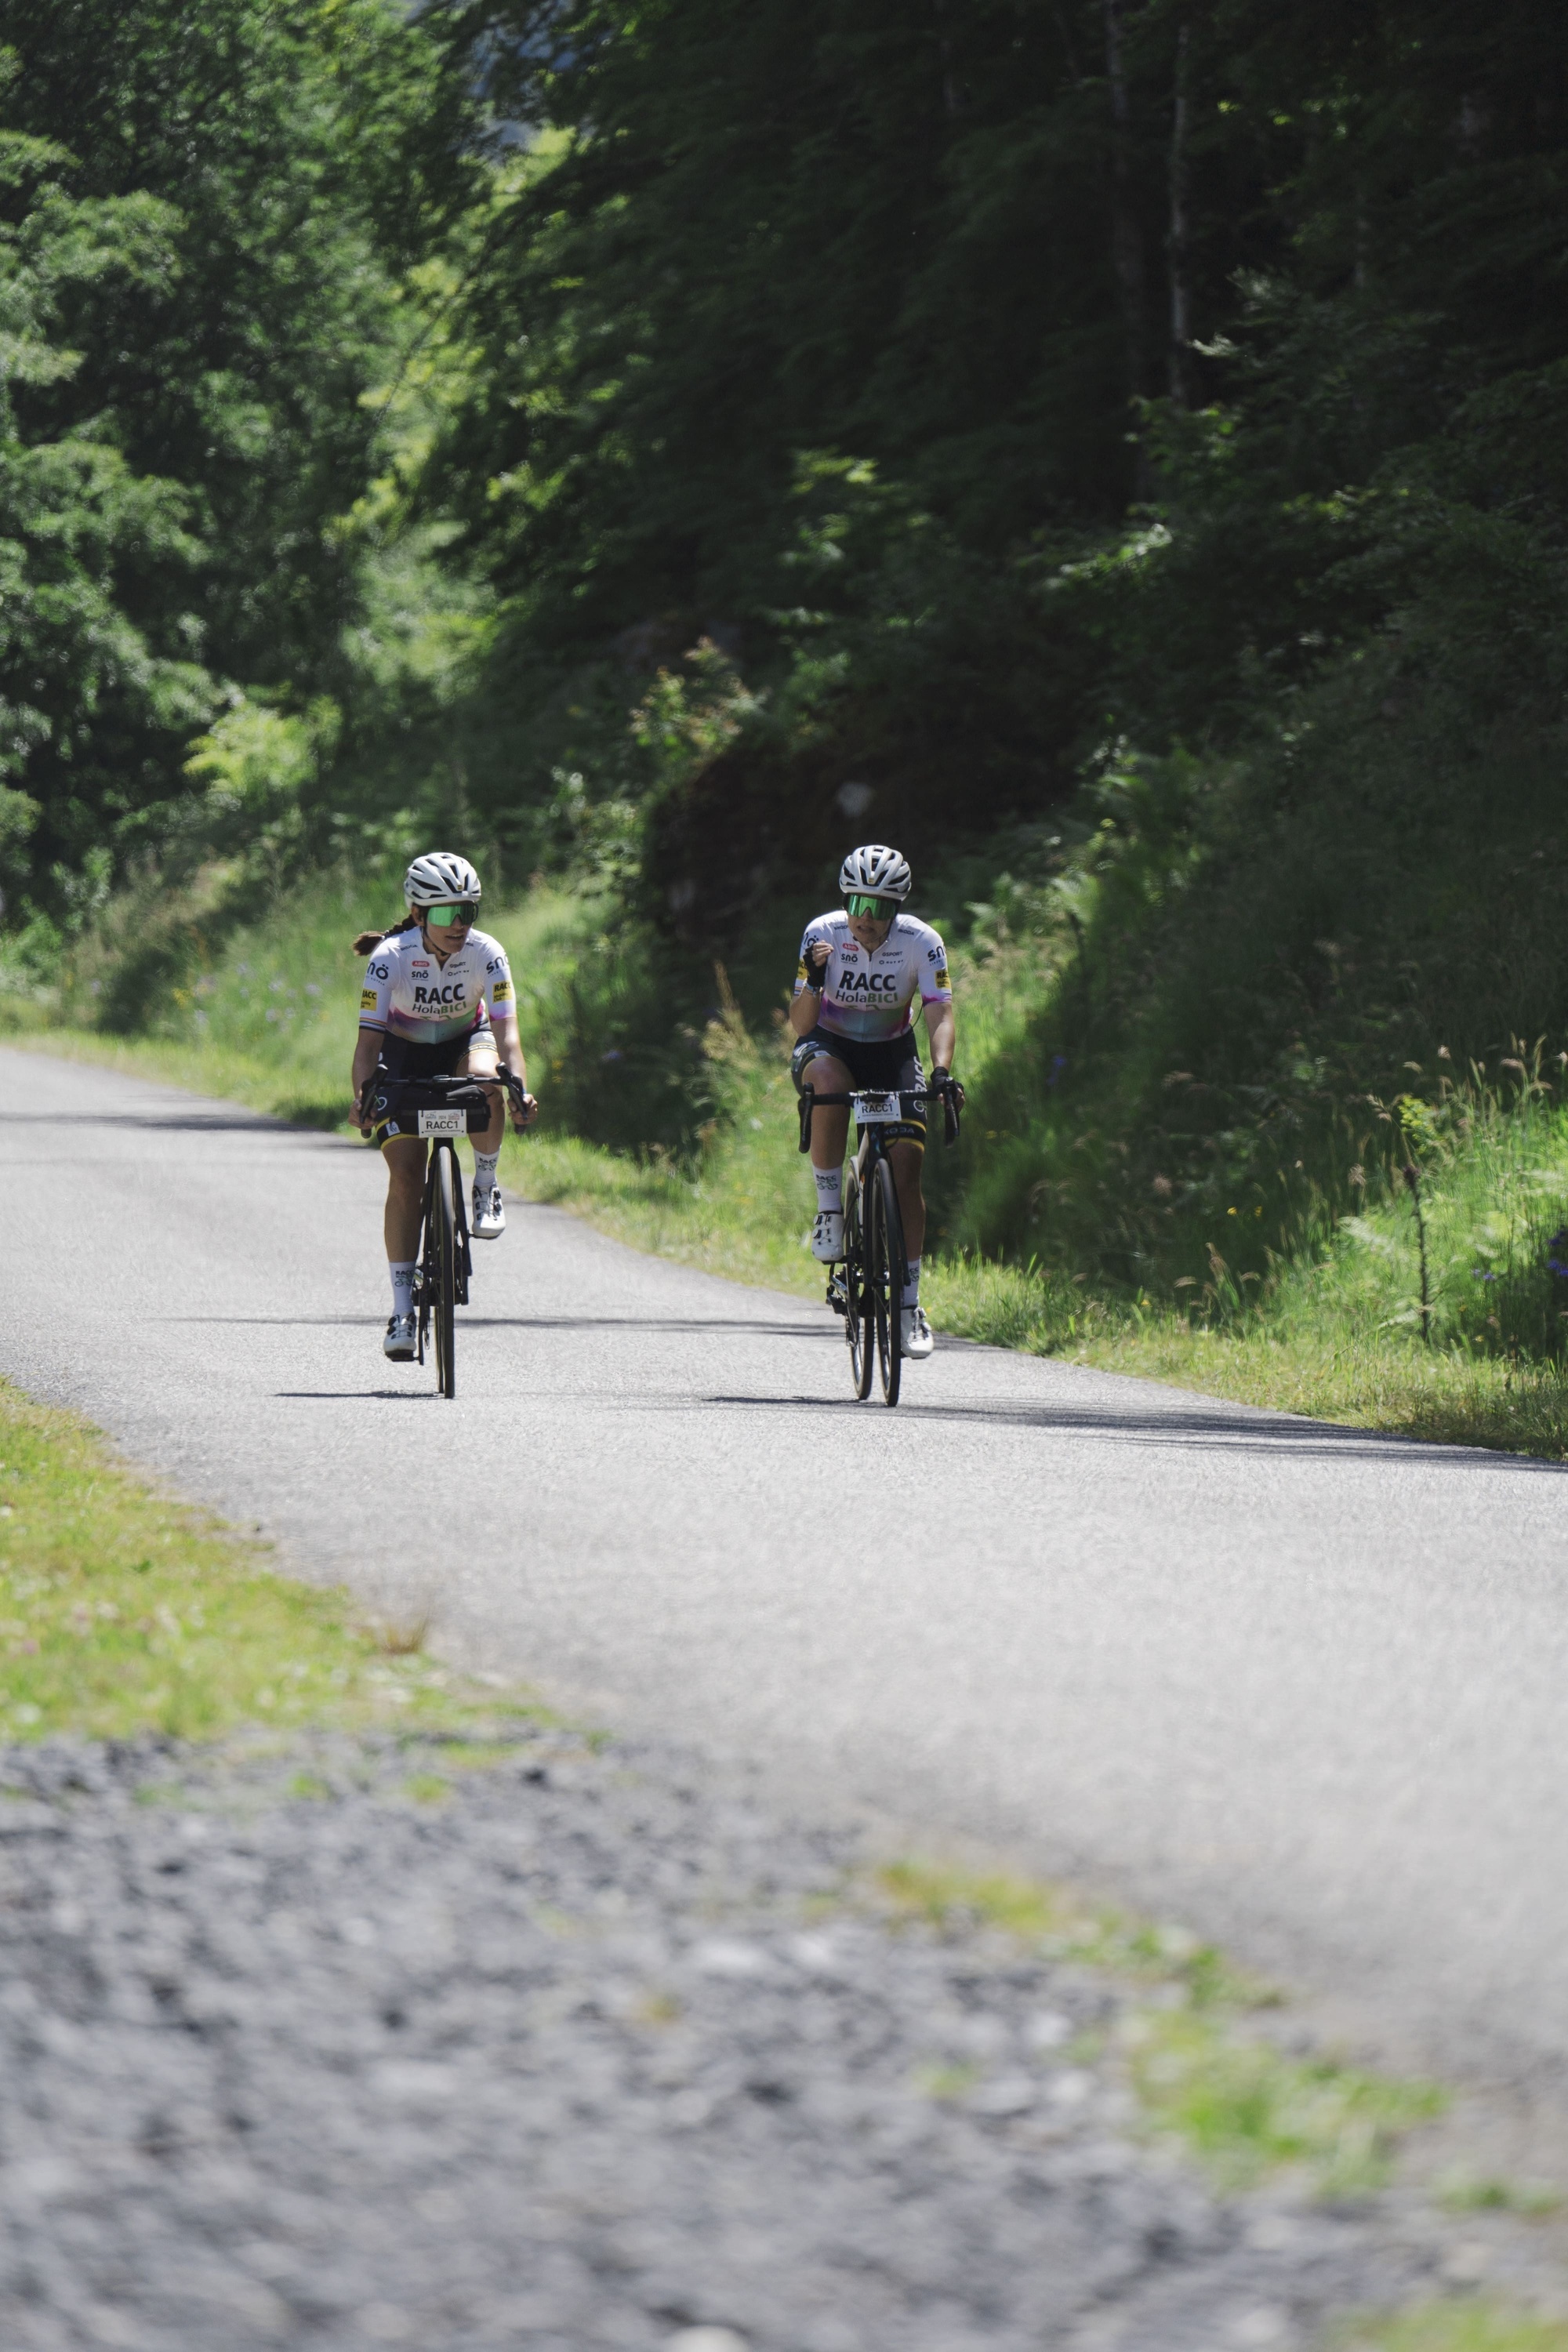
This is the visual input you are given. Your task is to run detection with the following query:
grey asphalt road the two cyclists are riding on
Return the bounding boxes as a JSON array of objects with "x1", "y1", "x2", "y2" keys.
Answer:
[{"x1": 0, "y1": 1051, "x2": 1568, "y2": 2110}]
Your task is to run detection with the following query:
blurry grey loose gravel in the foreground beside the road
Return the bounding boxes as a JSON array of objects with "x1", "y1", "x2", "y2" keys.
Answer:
[{"x1": 0, "y1": 1729, "x2": 1542, "y2": 2352}]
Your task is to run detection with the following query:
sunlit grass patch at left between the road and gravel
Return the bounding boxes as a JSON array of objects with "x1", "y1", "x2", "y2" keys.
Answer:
[{"x1": 0, "y1": 1383, "x2": 527, "y2": 1750}]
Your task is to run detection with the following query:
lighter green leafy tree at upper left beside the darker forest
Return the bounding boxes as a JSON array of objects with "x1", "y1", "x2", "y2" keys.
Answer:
[{"x1": 0, "y1": 0, "x2": 463, "y2": 920}]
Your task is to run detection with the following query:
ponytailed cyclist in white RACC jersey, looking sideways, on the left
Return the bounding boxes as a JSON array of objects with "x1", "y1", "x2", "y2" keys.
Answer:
[{"x1": 353, "y1": 849, "x2": 539, "y2": 1364}]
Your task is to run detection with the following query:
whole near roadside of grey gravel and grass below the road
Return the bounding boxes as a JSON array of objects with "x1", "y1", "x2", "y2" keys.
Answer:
[{"x1": 0, "y1": 1390, "x2": 1568, "y2": 2352}]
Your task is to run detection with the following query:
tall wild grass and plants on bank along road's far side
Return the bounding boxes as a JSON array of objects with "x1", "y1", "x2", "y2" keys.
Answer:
[{"x1": 0, "y1": 877, "x2": 1568, "y2": 1454}]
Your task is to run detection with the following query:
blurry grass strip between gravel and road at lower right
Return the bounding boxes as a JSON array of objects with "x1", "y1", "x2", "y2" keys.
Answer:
[{"x1": 874, "y1": 1860, "x2": 1446, "y2": 2197}]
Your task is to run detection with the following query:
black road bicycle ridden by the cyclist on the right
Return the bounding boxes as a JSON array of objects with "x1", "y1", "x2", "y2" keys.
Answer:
[{"x1": 799, "y1": 1087, "x2": 964, "y2": 1404}]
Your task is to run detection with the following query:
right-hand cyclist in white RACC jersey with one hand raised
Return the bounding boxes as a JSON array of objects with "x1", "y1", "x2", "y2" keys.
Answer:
[{"x1": 789, "y1": 842, "x2": 954, "y2": 1362}]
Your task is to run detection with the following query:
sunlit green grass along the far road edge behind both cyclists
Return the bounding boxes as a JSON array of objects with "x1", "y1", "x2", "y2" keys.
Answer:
[{"x1": 0, "y1": 866, "x2": 1568, "y2": 1458}]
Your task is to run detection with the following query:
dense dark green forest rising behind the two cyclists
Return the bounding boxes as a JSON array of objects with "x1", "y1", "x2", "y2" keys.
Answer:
[{"x1": 0, "y1": 0, "x2": 1568, "y2": 1308}]
